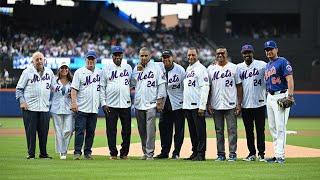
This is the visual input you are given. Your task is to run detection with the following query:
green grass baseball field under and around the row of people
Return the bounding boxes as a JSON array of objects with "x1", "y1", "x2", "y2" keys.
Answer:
[{"x1": 0, "y1": 118, "x2": 320, "y2": 179}]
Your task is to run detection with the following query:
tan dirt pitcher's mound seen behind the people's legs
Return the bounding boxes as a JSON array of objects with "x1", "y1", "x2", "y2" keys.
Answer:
[{"x1": 80, "y1": 138, "x2": 320, "y2": 159}]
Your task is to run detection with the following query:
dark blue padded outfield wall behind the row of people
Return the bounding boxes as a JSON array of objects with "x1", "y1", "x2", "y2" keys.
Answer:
[{"x1": 0, "y1": 90, "x2": 320, "y2": 117}]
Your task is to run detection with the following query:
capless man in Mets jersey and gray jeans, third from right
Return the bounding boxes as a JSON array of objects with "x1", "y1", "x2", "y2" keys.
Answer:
[{"x1": 208, "y1": 47, "x2": 242, "y2": 161}]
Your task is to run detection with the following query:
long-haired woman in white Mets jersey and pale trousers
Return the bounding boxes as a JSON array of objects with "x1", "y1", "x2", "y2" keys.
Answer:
[{"x1": 50, "y1": 62, "x2": 74, "y2": 160}]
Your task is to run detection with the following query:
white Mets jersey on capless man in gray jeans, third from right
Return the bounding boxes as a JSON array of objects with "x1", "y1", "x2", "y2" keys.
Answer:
[{"x1": 208, "y1": 62, "x2": 241, "y2": 110}]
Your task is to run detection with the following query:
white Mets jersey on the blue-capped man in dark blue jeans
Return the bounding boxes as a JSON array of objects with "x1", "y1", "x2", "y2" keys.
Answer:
[{"x1": 71, "y1": 67, "x2": 101, "y2": 113}]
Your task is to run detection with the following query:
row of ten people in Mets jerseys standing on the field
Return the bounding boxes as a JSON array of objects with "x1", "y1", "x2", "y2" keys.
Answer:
[{"x1": 17, "y1": 41, "x2": 293, "y2": 163}]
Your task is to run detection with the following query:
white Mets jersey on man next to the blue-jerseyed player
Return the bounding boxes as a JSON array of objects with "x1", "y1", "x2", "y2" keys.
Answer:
[{"x1": 237, "y1": 59, "x2": 267, "y2": 108}]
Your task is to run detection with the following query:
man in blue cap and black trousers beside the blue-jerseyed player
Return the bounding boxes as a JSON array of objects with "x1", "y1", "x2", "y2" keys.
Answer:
[{"x1": 237, "y1": 44, "x2": 267, "y2": 161}]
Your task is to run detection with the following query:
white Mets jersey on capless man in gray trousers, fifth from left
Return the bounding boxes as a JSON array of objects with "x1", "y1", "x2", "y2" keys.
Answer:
[{"x1": 132, "y1": 61, "x2": 166, "y2": 110}]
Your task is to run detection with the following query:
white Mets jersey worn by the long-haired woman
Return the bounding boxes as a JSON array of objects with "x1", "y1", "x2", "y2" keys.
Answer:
[{"x1": 50, "y1": 77, "x2": 72, "y2": 114}]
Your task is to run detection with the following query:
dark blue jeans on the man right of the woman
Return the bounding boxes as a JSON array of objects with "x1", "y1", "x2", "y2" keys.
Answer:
[{"x1": 74, "y1": 111, "x2": 97, "y2": 155}]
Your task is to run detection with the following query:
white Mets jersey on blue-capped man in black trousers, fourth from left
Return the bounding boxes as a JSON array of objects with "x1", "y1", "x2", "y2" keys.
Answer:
[{"x1": 100, "y1": 62, "x2": 132, "y2": 108}]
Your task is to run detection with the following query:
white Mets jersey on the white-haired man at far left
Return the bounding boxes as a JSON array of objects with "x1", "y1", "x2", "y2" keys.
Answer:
[{"x1": 16, "y1": 65, "x2": 54, "y2": 112}]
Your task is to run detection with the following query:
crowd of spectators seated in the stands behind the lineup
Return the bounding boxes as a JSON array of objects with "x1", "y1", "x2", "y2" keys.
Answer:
[{"x1": 0, "y1": 26, "x2": 213, "y2": 69}]
